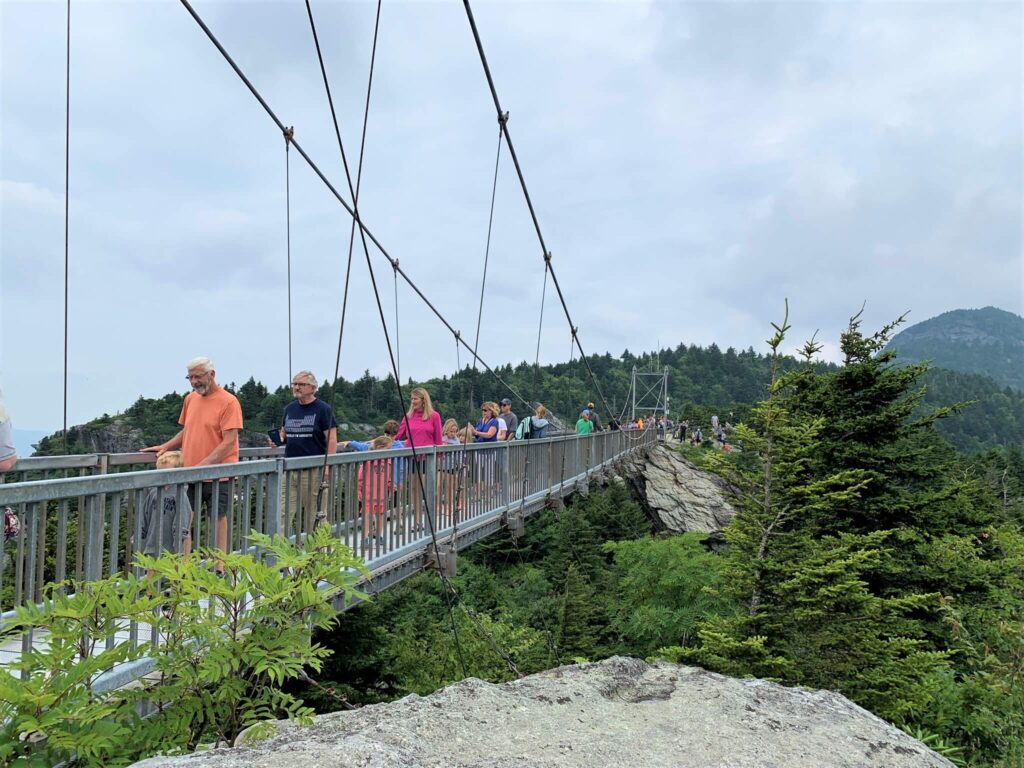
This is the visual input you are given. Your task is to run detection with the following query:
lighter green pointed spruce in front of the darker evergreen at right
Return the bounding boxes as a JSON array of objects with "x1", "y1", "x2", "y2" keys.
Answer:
[{"x1": 667, "y1": 305, "x2": 946, "y2": 719}]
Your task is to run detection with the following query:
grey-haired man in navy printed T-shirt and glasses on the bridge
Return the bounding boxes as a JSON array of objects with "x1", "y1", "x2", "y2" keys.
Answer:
[{"x1": 281, "y1": 371, "x2": 338, "y2": 534}]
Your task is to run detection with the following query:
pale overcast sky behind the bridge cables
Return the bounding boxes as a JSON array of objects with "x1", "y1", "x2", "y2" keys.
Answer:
[{"x1": 0, "y1": 0, "x2": 1024, "y2": 438}]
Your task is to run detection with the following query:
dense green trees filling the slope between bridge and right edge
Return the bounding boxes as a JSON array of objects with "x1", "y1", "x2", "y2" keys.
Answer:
[{"x1": 301, "y1": 313, "x2": 1024, "y2": 768}]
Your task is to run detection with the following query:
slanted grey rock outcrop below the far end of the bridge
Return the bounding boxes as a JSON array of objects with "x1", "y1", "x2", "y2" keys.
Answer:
[{"x1": 616, "y1": 444, "x2": 736, "y2": 534}]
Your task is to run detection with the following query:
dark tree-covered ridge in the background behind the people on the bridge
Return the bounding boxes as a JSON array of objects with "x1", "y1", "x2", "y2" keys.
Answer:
[{"x1": 32, "y1": 335, "x2": 1024, "y2": 455}]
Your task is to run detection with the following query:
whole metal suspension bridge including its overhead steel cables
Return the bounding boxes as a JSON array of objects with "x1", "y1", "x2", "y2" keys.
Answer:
[{"x1": 0, "y1": 0, "x2": 668, "y2": 688}]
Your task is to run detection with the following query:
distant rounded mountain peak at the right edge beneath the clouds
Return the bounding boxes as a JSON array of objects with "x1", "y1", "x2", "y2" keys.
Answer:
[{"x1": 887, "y1": 306, "x2": 1024, "y2": 391}]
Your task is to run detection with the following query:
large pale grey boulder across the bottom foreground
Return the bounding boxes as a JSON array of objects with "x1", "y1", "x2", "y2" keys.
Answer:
[{"x1": 136, "y1": 658, "x2": 952, "y2": 768}]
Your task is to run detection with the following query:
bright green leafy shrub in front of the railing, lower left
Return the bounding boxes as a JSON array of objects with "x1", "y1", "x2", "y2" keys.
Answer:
[{"x1": 0, "y1": 525, "x2": 367, "y2": 766}]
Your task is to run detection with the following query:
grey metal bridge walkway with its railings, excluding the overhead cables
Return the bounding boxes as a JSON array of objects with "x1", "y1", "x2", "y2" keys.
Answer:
[{"x1": 0, "y1": 429, "x2": 657, "y2": 689}]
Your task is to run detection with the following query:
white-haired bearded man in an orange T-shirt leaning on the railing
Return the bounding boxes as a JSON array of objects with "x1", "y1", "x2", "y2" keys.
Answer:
[{"x1": 142, "y1": 357, "x2": 242, "y2": 551}]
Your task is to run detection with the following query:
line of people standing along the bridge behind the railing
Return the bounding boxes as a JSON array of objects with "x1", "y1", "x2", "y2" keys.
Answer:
[{"x1": 130, "y1": 357, "x2": 614, "y2": 550}]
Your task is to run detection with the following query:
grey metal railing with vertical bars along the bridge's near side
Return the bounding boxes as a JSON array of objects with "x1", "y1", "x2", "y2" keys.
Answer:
[{"x1": 0, "y1": 430, "x2": 656, "y2": 638}]
